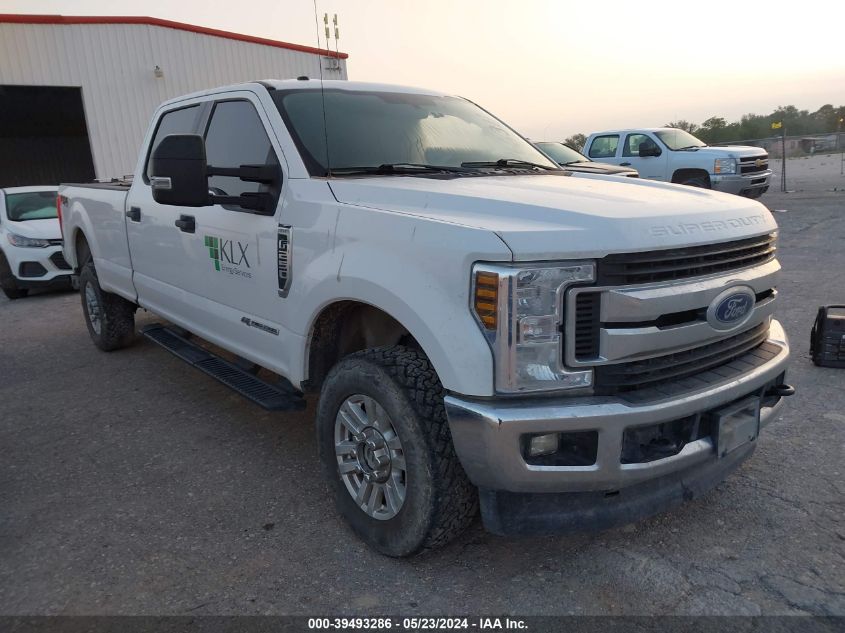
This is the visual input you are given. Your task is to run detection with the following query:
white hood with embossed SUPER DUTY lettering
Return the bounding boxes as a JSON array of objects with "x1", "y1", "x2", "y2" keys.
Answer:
[{"x1": 329, "y1": 174, "x2": 777, "y2": 260}]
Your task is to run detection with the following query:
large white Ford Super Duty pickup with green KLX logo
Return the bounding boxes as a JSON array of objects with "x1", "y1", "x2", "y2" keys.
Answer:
[{"x1": 59, "y1": 79, "x2": 792, "y2": 556}]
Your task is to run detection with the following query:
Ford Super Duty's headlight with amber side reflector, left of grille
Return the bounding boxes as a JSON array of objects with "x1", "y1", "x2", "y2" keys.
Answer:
[{"x1": 472, "y1": 262, "x2": 595, "y2": 393}]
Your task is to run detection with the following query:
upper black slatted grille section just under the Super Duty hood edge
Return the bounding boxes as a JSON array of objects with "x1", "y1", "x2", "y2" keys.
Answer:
[{"x1": 598, "y1": 233, "x2": 777, "y2": 286}]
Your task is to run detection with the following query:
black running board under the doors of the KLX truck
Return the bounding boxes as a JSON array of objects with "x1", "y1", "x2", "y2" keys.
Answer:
[{"x1": 141, "y1": 323, "x2": 305, "y2": 411}]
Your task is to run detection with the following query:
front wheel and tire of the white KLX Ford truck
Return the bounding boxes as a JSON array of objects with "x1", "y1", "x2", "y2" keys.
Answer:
[{"x1": 317, "y1": 345, "x2": 478, "y2": 557}]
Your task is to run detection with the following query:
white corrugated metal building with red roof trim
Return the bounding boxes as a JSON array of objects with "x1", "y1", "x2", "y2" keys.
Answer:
[{"x1": 0, "y1": 14, "x2": 347, "y2": 187}]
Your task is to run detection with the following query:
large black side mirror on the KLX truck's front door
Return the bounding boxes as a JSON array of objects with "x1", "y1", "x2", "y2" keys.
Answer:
[{"x1": 150, "y1": 134, "x2": 211, "y2": 207}]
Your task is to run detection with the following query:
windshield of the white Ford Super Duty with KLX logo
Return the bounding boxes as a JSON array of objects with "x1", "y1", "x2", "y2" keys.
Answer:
[{"x1": 272, "y1": 89, "x2": 558, "y2": 176}]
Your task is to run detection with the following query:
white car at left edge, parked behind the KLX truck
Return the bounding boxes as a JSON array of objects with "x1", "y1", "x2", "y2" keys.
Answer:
[{"x1": 0, "y1": 187, "x2": 71, "y2": 299}]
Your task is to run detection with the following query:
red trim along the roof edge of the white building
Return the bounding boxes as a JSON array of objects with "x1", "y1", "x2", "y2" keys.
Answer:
[{"x1": 0, "y1": 13, "x2": 349, "y2": 59}]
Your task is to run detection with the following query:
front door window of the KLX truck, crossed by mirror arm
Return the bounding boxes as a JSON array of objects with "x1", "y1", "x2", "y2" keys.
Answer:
[{"x1": 205, "y1": 101, "x2": 279, "y2": 196}]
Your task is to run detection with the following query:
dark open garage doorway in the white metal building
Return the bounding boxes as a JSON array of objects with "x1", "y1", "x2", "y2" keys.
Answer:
[{"x1": 0, "y1": 86, "x2": 94, "y2": 187}]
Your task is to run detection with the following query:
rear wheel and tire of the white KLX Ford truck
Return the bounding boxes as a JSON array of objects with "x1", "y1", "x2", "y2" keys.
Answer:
[{"x1": 79, "y1": 260, "x2": 135, "y2": 352}]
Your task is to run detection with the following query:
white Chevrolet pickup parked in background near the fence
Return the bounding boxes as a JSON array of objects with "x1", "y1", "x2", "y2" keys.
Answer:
[{"x1": 584, "y1": 127, "x2": 772, "y2": 198}]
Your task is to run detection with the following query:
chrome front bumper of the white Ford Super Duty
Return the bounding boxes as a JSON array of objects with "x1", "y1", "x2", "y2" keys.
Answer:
[{"x1": 446, "y1": 321, "x2": 789, "y2": 493}]
